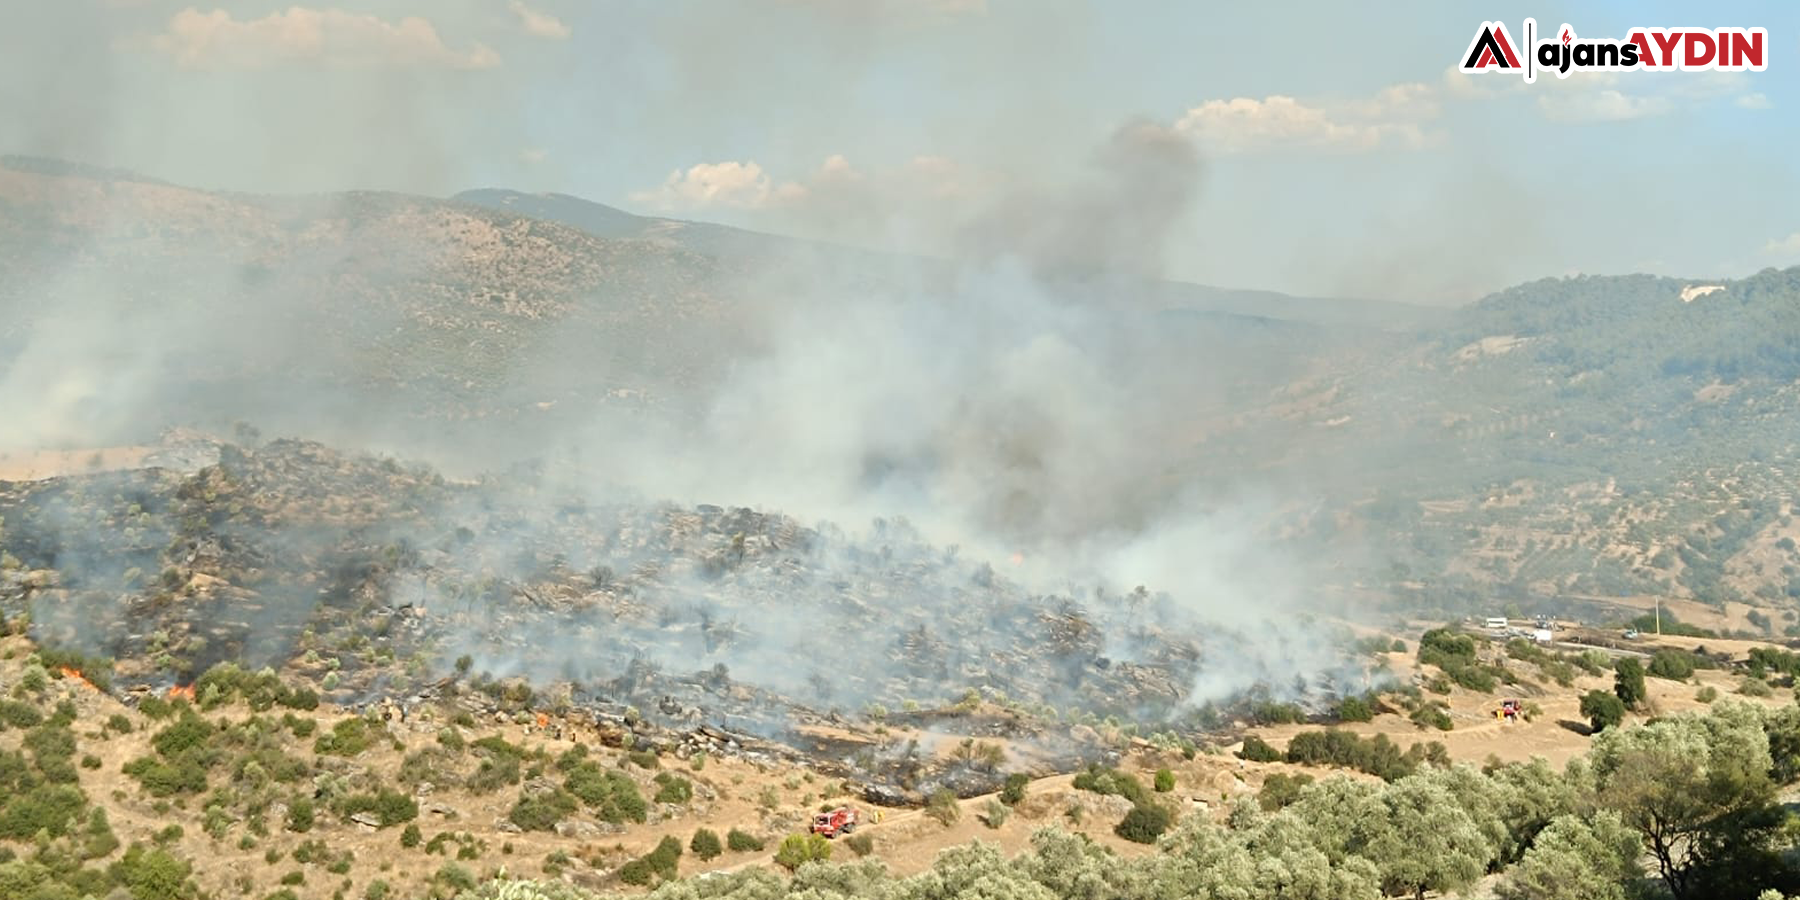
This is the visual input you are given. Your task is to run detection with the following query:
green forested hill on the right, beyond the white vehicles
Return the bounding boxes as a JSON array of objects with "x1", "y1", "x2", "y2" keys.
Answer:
[{"x1": 1346, "y1": 268, "x2": 1800, "y2": 619}]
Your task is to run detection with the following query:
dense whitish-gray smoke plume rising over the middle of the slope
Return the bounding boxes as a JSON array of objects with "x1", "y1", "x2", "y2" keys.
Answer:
[{"x1": 478, "y1": 122, "x2": 1343, "y2": 700}]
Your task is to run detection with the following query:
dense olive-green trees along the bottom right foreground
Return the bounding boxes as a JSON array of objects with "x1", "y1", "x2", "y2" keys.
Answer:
[{"x1": 442, "y1": 700, "x2": 1800, "y2": 900}]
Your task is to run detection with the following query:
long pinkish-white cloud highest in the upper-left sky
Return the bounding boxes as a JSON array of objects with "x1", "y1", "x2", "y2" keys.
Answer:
[{"x1": 149, "y1": 7, "x2": 500, "y2": 70}]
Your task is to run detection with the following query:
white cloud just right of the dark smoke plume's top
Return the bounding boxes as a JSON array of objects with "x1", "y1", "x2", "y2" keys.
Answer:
[{"x1": 1175, "y1": 90, "x2": 1438, "y2": 155}]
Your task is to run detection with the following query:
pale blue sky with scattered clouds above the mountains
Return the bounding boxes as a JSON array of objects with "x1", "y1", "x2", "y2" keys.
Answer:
[{"x1": 0, "y1": 0, "x2": 1800, "y2": 304}]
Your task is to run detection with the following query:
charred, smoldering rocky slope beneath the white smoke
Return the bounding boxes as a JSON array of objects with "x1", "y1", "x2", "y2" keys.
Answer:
[{"x1": 0, "y1": 441, "x2": 1252, "y2": 734}]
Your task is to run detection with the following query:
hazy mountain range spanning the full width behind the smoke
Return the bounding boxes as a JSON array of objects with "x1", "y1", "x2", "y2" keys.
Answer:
[{"x1": 10, "y1": 160, "x2": 1800, "y2": 619}]
